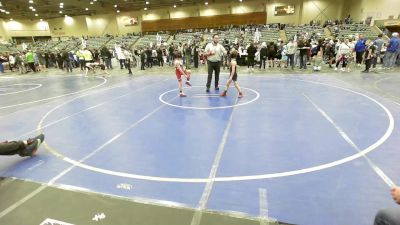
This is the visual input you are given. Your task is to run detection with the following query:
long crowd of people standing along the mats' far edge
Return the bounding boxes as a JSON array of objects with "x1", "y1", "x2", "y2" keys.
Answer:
[{"x1": 0, "y1": 21, "x2": 400, "y2": 77}]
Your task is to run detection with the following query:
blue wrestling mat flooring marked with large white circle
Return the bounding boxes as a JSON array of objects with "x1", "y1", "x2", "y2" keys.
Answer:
[{"x1": 0, "y1": 75, "x2": 400, "y2": 225}]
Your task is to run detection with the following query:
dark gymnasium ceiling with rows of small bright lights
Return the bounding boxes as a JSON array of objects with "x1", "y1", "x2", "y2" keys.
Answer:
[{"x1": 0, "y1": 0, "x2": 244, "y2": 19}]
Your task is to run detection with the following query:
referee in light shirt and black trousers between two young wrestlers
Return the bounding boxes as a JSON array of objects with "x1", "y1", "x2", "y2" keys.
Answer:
[{"x1": 205, "y1": 34, "x2": 226, "y2": 92}]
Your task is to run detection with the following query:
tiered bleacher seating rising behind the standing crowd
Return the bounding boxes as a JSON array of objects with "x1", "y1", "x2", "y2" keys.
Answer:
[{"x1": 0, "y1": 24, "x2": 384, "y2": 53}]
